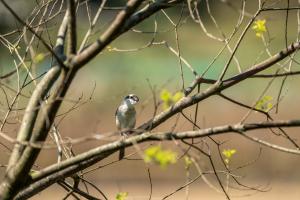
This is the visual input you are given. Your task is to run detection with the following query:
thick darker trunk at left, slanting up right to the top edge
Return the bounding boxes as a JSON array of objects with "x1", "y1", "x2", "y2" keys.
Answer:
[{"x1": 0, "y1": 0, "x2": 173, "y2": 199}]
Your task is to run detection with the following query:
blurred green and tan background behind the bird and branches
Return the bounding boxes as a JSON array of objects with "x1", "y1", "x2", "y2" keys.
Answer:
[{"x1": 0, "y1": 0, "x2": 300, "y2": 200}]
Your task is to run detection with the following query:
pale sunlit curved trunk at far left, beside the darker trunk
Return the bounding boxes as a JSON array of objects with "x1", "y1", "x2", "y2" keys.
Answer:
[{"x1": 0, "y1": 5, "x2": 67, "y2": 199}]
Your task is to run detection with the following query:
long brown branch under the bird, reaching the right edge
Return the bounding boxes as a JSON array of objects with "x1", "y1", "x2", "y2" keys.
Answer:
[{"x1": 17, "y1": 120, "x2": 300, "y2": 198}]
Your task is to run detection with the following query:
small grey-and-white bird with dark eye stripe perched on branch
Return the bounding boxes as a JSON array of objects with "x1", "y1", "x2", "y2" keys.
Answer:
[{"x1": 115, "y1": 94, "x2": 139, "y2": 160}]
